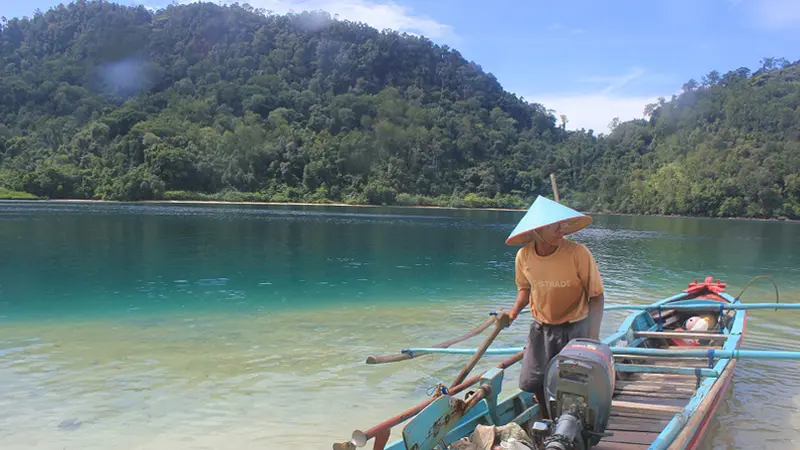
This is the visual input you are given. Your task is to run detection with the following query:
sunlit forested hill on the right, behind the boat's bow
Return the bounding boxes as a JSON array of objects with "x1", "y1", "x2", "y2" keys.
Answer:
[{"x1": 592, "y1": 58, "x2": 800, "y2": 218}]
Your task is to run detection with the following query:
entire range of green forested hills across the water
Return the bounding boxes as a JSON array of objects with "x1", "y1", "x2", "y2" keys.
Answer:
[{"x1": 0, "y1": 1, "x2": 800, "y2": 218}]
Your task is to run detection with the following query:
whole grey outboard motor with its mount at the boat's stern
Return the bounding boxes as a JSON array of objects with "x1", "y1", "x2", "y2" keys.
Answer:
[{"x1": 530, "y1": 339, "x2": 616, "y2": 450}]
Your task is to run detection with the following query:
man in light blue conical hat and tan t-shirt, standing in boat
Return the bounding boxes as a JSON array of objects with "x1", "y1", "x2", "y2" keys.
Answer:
[{"x1": 506, "y1": 196, "x2": 605, "y2": 418}]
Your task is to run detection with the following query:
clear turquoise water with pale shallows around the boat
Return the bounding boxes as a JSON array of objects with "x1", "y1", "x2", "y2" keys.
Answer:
[{"x1": 0, "y1": 202, "x2": 800, "y2": 449}]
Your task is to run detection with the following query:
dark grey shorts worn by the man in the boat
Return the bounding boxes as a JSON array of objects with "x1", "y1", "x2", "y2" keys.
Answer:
[{"x1": 519, "y1": 318, "x2": 589, "y2": 392}]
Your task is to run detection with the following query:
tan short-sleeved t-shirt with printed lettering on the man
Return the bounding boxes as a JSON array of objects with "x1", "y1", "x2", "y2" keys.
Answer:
[{"x1": 516, "y1": 239, "x2": 603, "y2": 325}]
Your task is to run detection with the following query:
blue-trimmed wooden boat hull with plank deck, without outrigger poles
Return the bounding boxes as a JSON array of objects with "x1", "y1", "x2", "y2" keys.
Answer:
[{"x1": 346, "y1": 278, "x2": 747, "y2": 450}]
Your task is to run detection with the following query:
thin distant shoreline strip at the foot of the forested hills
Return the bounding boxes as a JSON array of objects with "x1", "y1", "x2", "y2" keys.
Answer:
[{"x1": 0, "y1": 198, "x2": 800, "y2": 223}]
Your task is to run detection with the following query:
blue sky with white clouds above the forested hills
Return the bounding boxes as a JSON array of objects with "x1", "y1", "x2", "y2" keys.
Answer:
[{"x1": 0, "y1": 0, "x2": 800, "y2": 133}]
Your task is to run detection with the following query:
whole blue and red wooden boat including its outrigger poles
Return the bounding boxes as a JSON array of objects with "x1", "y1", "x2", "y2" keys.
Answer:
[{"x1": 333, "y1": 277, "x2": 800, "y2": 450}]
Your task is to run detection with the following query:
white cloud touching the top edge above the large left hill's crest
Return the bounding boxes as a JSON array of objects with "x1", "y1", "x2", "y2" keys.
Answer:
[{"x1": 167, "y1": 0, "x2": 456, "y2": 40}]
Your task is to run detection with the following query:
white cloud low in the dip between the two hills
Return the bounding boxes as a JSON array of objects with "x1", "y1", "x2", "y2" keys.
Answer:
[{"x1": 524, "y1": 67, "x2": 672, "y2": 134}]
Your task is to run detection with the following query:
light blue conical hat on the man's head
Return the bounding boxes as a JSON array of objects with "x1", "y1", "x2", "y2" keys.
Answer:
[{"x1": 506, "y1": 195, "x2": 592, "y2": 245}]
